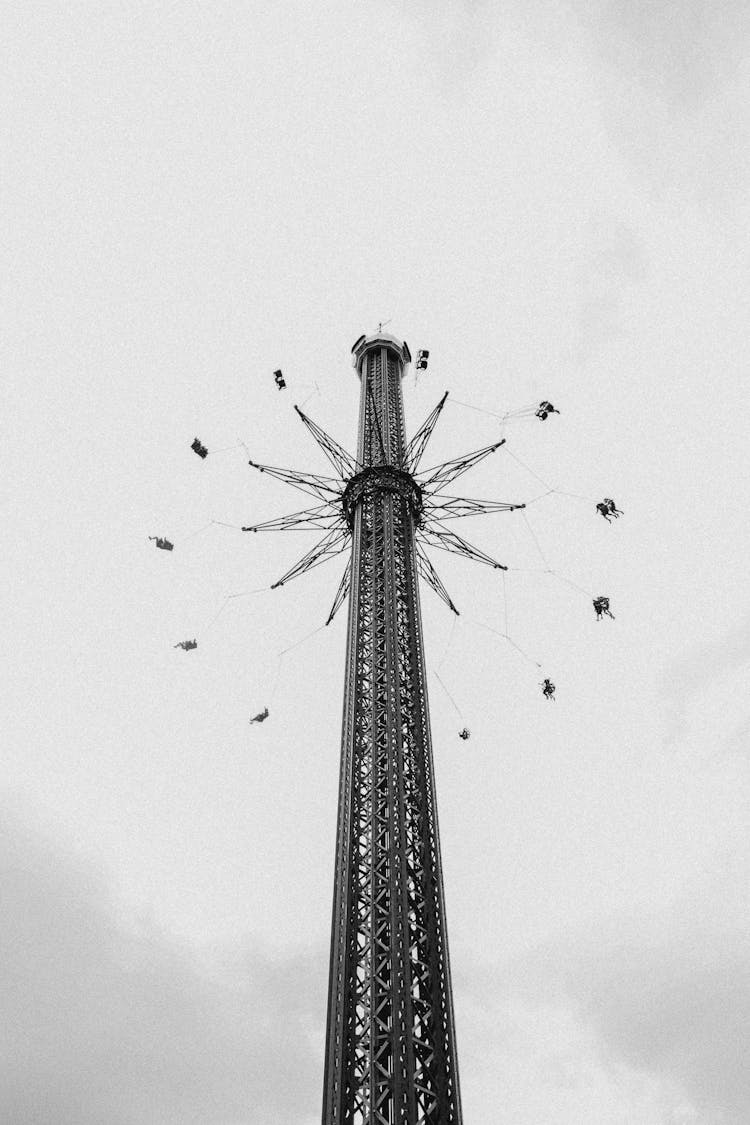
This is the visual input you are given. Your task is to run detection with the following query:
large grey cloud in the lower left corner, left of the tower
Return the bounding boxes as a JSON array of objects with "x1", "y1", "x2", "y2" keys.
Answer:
[{"x1": 0, "y1": 822, "x2": 325, "y2": 1125}]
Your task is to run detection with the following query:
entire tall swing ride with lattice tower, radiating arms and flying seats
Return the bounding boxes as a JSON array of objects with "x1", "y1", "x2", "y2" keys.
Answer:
[{"x1": 151, "y1": 325, "x2": 622, "y2": 1125}]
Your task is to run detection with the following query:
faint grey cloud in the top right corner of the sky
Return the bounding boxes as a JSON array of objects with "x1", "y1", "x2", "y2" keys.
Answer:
[{"x1": 573, "y1": 0, "x2": 750, "y2": 209}]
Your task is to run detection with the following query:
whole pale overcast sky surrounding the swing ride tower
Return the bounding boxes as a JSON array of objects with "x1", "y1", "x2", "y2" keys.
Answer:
[{"x1": 0, "y1": 0, "x2": 750, "y2": 1125}]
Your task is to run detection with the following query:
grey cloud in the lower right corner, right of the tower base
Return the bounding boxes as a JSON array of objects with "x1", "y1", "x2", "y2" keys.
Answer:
[{"x1": 481, "y1": 851, "x2": 750, "y2": 1125}]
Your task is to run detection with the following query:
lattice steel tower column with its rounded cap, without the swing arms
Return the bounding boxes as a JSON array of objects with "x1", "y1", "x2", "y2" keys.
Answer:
[{"x1": 323, "y1": 334, "x2": 461, "y2": 1125}]
